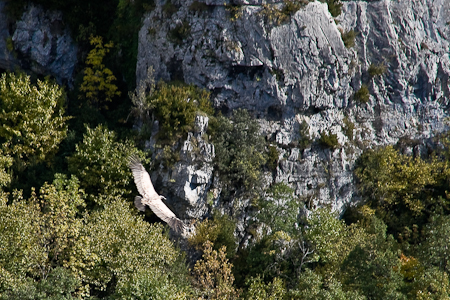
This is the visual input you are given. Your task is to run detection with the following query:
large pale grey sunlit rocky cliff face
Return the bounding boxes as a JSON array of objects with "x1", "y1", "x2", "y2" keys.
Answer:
[{"x1": 136, "y1": 0, "x2": 450, "y2": 217}]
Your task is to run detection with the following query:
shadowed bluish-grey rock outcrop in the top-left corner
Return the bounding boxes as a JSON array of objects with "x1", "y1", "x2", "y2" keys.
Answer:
[{"x1": 0, "y1": 2, "x2": 77, "y2": 84}]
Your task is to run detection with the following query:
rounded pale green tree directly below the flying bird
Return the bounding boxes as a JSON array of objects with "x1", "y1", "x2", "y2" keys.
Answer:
[{"x1": 78, "y1": 197, "x2": 190, "y2": 299}]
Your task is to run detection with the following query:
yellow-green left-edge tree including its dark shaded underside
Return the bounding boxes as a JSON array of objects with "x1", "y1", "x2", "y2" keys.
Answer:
[{"x1": 0, "y1": 73, "x2": 70, "y2": 194}]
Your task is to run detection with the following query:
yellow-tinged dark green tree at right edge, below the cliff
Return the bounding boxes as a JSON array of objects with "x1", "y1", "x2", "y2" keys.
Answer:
[{"x1": 355, "y1": 146, "x2": 449, "y2": 232}]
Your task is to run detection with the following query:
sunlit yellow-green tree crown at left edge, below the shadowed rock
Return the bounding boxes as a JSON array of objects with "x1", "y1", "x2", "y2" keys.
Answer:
[{"x1": 0, "y1": 73, "x2": 69, "y2": 169}]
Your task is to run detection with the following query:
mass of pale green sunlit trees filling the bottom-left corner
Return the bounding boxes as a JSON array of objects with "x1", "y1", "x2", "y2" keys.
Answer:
[{"x1": 0, "y1": 175, "x2": 190, "y2": 299}]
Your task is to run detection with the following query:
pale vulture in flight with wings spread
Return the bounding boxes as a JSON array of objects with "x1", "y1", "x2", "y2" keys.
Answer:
[{"x1": 128, "y1": 155, "x2": 185, "y2": 233}]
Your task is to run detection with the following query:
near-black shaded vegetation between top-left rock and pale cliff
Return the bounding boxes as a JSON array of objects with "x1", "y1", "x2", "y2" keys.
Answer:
[{"x1": 6, "y1": 0, "x2": 155, "y2": 89}]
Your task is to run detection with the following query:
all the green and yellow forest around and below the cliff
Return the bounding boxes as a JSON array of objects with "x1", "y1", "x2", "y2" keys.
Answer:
[{"x1": 0, "y1": 0, "x2": 450, "y2": 300}]
